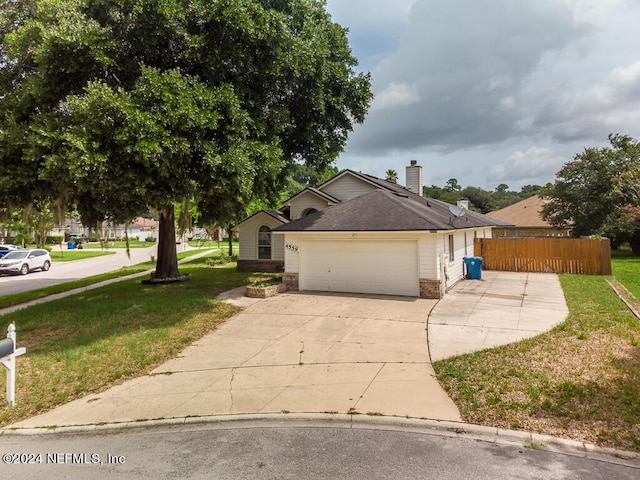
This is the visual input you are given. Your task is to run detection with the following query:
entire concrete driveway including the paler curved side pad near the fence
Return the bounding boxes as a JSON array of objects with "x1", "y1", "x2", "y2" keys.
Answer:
[{"x1": 3, "y1": 272, "x2": 567, "y2": 428}]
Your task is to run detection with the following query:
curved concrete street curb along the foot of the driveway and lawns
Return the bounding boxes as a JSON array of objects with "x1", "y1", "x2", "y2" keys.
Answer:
[{"x1": 0, "y1": 413, "x2": 640, "y2": 470}]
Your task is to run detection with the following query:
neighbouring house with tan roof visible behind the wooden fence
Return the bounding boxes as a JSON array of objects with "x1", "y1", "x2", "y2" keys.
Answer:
[{"x1": 487, "y1": 195, "x2": 571, "y2": 237}]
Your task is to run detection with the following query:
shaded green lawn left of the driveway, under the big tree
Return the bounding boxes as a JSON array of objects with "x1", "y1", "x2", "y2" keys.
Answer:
[{"x1": 0, "y1": 253, "x2": 272, "y2": 426}]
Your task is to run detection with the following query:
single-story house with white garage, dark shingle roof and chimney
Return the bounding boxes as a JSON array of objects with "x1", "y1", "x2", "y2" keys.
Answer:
[{"x1": 234, "y1": 160, "x2": 506, "y2": 298}]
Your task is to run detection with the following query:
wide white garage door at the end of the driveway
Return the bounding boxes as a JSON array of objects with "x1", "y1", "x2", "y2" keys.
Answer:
[{"x1": 299, "y1": 240, "x2": 419, "y2": 297}]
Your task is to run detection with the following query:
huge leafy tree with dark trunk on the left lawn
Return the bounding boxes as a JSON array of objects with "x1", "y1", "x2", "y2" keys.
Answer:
[{"x1": 0, "y1": 0, "x2": 371, "y2": 277}]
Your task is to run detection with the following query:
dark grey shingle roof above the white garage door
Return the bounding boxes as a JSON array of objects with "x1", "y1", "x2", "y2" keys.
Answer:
[{"x1": 275, "y1": 187, "x2": 506, "y2": 232}]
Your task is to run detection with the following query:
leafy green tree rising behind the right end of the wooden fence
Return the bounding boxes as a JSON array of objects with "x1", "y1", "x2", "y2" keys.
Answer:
[{"x1": 543, "y1": 134, "x2": 640, "y2": 254}]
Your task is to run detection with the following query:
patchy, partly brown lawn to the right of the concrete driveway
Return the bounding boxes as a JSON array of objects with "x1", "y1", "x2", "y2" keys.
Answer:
[{"x1": 434, "y1": 255, "x2": 640, "y2": 451}]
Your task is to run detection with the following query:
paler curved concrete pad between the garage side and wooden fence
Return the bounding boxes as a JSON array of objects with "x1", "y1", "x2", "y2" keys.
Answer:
[{"x1": 428, "y1": 271, "x2": 569, "y2": 362}]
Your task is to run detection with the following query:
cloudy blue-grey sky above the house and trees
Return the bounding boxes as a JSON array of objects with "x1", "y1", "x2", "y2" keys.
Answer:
[{"x1": 327, "y1": 0, "x2": 640, "y2": 190}]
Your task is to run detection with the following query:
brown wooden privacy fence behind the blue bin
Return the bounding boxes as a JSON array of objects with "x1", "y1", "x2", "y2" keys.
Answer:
[{"x1": 474, "y1": 237, "x2": 611, "y2": 275}]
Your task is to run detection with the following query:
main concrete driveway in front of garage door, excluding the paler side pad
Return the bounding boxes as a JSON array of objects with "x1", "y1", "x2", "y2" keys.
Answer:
[{"x1": 8, "y1": 289, "x2": 460, "y2": 427}]
